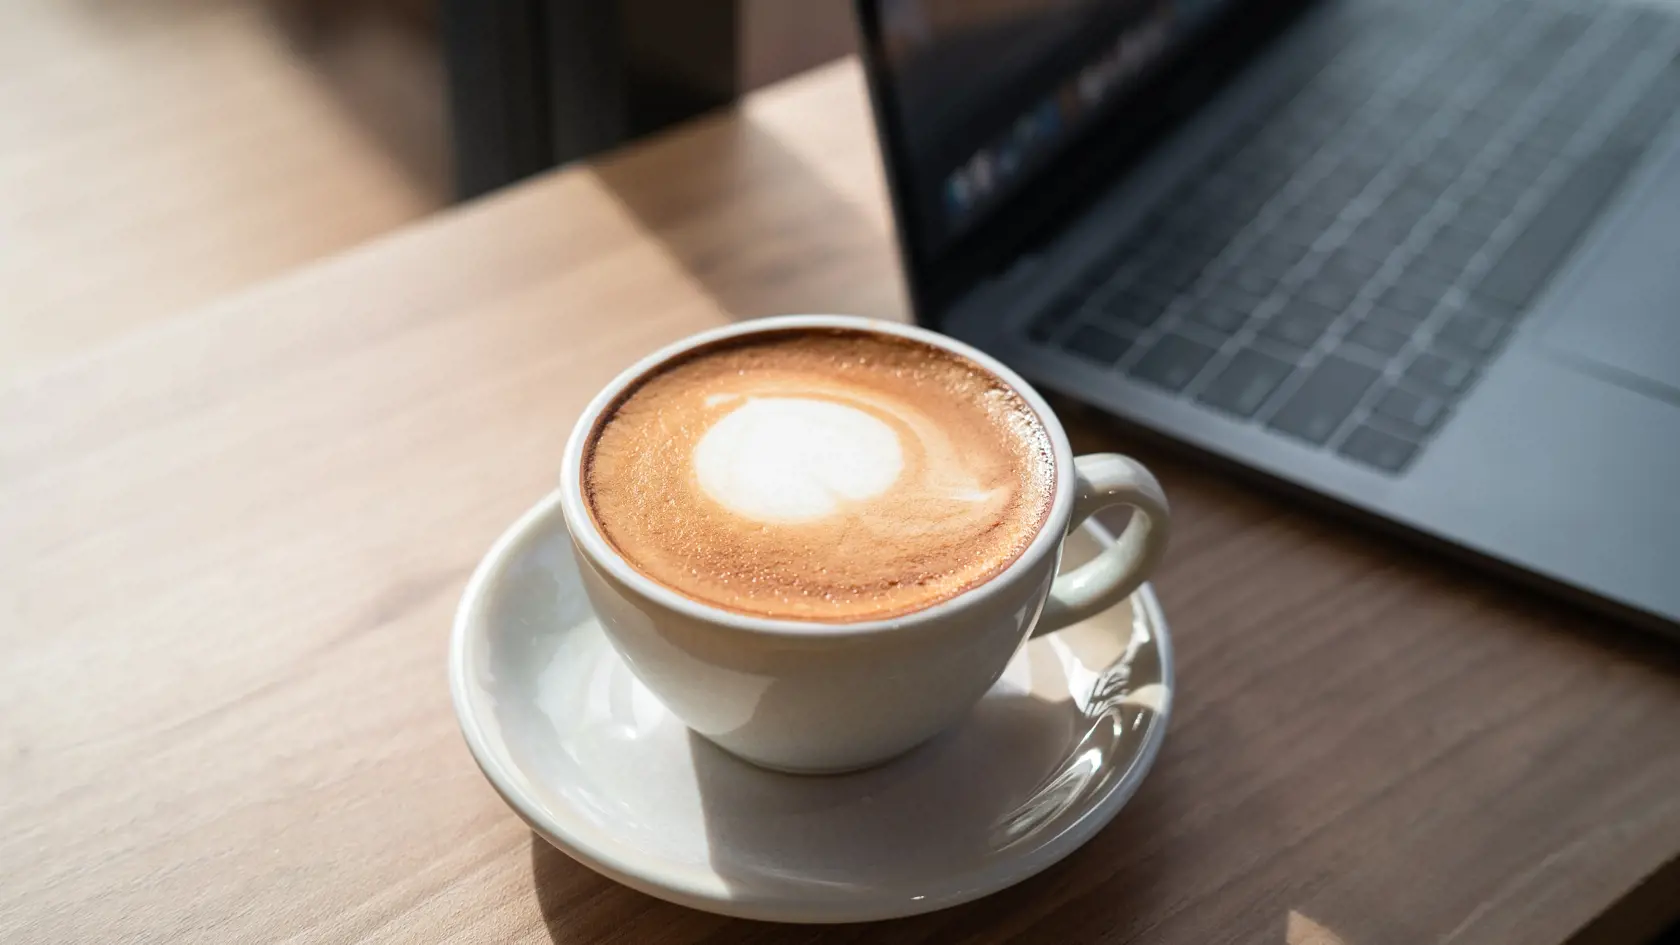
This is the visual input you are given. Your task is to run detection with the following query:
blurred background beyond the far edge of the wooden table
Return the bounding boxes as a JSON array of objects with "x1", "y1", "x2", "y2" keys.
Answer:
[{"x1": 0, "y1": 0, "x2": 853, "y2": 377}]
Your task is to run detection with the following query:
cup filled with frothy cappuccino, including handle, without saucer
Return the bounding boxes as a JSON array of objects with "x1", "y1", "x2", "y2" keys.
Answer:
[{"x1": 559, "y1": 314, "x2": 1169, "y2": 773}]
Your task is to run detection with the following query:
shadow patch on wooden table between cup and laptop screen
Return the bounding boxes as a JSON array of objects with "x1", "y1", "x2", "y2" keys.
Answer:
[{"x1": 593, "y1": 111, "x2": 909, "y2": 319}]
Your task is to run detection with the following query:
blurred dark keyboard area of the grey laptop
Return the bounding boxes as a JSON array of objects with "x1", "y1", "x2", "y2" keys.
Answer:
[{"x1": 1026, "y1": 0, "x2": 1680, "y2": 474}]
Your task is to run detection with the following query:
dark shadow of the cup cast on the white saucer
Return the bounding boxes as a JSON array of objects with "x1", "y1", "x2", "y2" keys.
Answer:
[{"x1": 689, "y1": 591, "x2": 1159, "y2": 881}]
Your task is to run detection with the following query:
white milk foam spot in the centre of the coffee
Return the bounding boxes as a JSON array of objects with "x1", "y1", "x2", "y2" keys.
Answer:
[{"x1": 694, "y1": 397, "x2": 904, "y2": 523}]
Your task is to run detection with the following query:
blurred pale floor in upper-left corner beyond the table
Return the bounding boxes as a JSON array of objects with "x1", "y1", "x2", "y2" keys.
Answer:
[{"x1": 0, "y1": 0, "x2": 449, "y2": 377}]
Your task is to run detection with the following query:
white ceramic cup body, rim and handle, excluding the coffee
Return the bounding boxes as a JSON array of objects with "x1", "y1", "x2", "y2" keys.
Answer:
[{"x1": 561, "y1": 314, "x2": 1169, "y2": 773}]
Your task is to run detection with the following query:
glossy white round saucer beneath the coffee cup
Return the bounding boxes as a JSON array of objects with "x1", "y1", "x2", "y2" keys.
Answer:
[{"x1": 449, "y1": 496, "x2": 1173, "y2": 921}]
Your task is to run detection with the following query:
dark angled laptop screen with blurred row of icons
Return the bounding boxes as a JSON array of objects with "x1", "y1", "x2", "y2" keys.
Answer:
[{"x1": 858, "y1": 0, "x2": 1278, "y2": 314}]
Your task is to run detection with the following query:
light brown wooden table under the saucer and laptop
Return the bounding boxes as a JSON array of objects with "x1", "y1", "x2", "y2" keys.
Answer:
[{"x1": 0, "y1": 64, "x2": 1680, "y2": 945}]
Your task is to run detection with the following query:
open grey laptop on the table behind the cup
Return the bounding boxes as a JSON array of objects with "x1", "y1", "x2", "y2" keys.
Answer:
[{"x1": 857, "y1": 0, "x2": 1680, "y2": 632}]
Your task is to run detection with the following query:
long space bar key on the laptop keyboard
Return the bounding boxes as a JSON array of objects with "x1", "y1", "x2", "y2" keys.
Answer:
[{"x1": 1475, "y1": 148, "x2": 1640, "y2": 308}]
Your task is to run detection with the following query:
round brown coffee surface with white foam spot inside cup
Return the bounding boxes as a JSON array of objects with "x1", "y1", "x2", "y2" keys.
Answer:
[{"x1": 583, "y1": 328, "x2": 1055, "y2": 622}]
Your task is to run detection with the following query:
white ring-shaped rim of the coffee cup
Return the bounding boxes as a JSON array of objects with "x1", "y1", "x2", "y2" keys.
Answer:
[{"x1": 559, "y1": 314, "x2": 1074, "y2": 637}]
